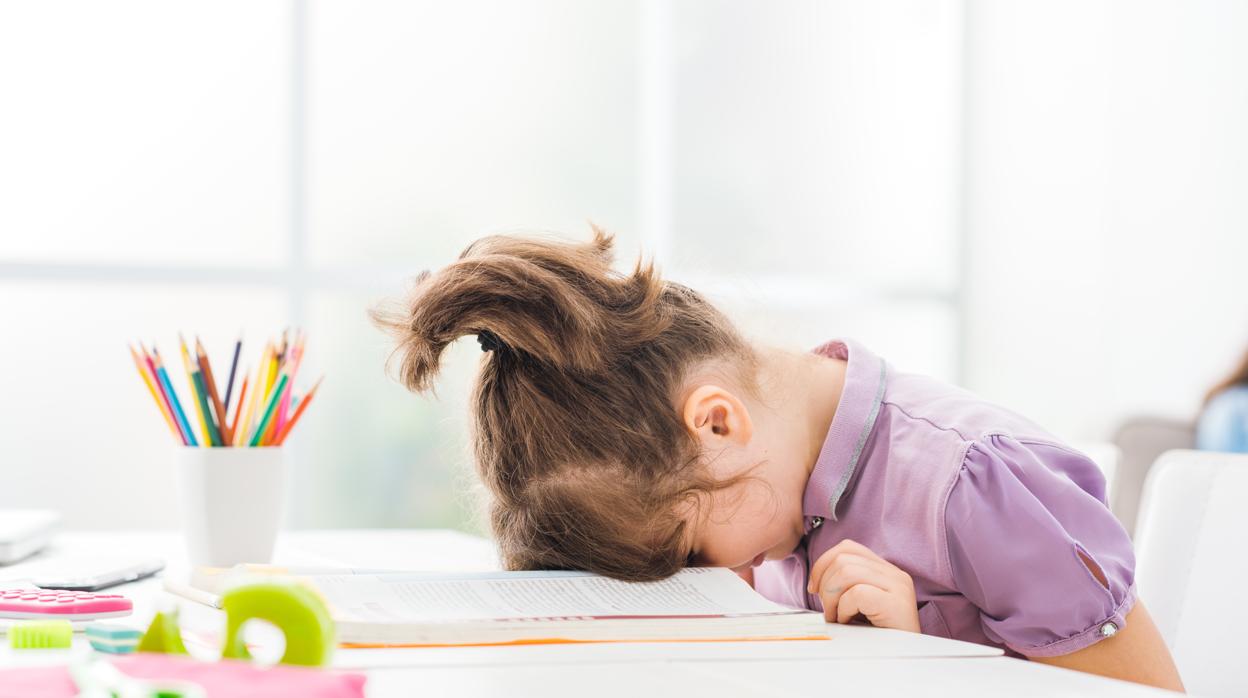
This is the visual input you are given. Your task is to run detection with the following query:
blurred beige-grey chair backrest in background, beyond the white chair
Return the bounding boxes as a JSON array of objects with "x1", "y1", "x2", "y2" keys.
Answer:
[{"x1": 1109, "y1": 417, "x2": 1196, "y2": 536}]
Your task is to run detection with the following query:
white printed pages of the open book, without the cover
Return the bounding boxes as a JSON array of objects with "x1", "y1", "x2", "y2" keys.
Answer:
[{"x1": 308, "y1": 567, "x2": 794, "y2": 622}]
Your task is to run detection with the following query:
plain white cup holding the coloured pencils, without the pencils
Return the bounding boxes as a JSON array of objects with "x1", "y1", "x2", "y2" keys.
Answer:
[{"x1": 177, "y1": 447, "x2": 287, "y2": 567}]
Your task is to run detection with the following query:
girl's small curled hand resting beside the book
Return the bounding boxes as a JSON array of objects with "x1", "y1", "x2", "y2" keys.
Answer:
[{"x1": 806, "y1": 538, "x2": 920, "y2": 633}]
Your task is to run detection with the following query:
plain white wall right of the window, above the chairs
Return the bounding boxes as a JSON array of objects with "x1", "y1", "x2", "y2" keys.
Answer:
[{"x1": 963, "y1": 0, "x2": 1248, "y2": 440}]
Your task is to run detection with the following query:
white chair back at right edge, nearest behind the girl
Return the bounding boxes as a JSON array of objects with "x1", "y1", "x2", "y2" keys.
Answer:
[{"x1": 1136, "y1": 451, "x2": 1248, "y2": 696}]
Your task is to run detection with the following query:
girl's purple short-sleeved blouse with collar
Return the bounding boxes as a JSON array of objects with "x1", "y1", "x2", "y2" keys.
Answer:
[{"x1": 754, "y1": 341, "x2": 1136, "y2": 657}]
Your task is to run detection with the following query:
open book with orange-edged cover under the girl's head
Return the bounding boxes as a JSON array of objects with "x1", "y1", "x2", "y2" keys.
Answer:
[{"x1": 303, "y1": 567, "x2": 829, "y2": 647}]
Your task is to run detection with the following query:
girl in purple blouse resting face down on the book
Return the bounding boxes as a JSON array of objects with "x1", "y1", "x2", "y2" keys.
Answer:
[{"x1": 373, "y1": 229, "x2": 1182, "y2": 689}]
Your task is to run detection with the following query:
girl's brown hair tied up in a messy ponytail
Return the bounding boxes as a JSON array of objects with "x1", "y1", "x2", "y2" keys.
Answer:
[{"x1": 372, "y1": 226, "x2": 756, "y2": 581}]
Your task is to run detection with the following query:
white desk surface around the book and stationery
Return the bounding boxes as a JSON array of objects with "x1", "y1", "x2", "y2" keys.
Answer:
[{"x1": 0, "y1": 531, "x2": 1169, "y2": 698}]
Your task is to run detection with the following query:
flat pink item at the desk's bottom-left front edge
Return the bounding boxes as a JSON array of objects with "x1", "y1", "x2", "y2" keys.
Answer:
[{"x1": 0, "y1": 653, "x2": 364, "y2": 698}]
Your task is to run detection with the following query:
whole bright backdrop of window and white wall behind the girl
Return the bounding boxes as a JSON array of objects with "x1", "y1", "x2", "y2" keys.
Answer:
[{"x1": 0, "y1": 0, "x2": 1248, "y2": 529}]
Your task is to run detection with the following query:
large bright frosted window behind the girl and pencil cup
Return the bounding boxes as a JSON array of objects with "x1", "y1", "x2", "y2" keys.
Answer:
[{"x1": 0, "y1": 0, "x2": 961, "y2": 529}]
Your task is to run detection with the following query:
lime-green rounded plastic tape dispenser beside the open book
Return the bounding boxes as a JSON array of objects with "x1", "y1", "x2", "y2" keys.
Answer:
[{"x1": 221, "y1": 582, "x2": 334, "y2": 667}]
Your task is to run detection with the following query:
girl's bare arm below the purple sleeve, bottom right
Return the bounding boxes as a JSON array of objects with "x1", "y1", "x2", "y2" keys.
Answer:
[{"x1": 1031, "y1": 601, "x2": 1184, "y2": 692}]
